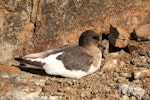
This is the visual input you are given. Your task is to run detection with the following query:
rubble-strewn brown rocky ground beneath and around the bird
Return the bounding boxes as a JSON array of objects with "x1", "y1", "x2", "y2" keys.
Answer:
[{"x1": 0, "y1": 40, "x2": 150, "y2": 100}]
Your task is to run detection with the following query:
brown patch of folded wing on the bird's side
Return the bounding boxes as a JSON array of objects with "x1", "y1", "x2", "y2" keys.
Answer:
[{"x1": 57, "y1": 46, "x2": 93, "y2": 71}]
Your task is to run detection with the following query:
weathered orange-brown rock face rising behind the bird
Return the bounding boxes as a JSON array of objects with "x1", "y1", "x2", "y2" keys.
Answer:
[{"x1": 0, "y1": 0, "x2": 150, "y2": 60}]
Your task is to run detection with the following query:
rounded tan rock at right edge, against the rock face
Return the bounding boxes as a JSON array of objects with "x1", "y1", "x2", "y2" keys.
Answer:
[{"x1": 135, "y1": 24, "x2": 150, "y2": 41}]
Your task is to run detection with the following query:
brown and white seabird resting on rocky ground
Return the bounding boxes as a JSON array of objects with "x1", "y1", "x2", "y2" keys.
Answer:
[{"x1": 16, "y1": 30, "x2": 105, "y2": 78}]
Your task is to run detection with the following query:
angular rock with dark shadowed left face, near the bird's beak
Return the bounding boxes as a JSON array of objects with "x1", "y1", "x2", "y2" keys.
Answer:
[{"x1": 108, "y1": 25, "x2": 129, "y2": 48}]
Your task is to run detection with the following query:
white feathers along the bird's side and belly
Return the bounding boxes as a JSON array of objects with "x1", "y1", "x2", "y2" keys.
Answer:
[{"x1": 43, "y1": 52, "x2": 101, "y2": 78}]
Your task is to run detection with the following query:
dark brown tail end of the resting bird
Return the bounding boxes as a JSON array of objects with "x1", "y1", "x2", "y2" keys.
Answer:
[{"x1": 15, "y1": 58, "x2": 44, "y2": 69}]
